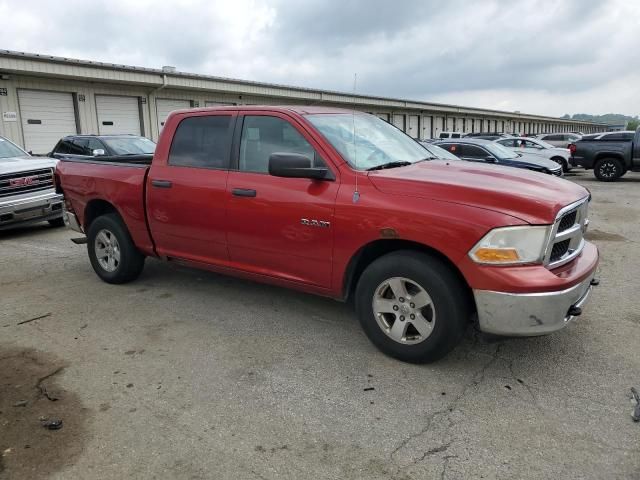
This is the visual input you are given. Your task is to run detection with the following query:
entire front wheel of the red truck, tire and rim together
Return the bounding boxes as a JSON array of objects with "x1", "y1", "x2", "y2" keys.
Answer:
[{"x1": 355, "y1": 251, "x2": 469, "y2": 363}]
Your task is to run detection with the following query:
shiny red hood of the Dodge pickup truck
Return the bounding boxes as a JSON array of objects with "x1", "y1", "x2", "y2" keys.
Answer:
[{"x1": 369, "y1": 160, "x2": 589, "y2": 225}]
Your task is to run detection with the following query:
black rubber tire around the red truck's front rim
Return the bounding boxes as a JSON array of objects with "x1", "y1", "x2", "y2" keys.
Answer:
[{"x1": 355, "y1": 251, "x2": 470, "y2": 363}]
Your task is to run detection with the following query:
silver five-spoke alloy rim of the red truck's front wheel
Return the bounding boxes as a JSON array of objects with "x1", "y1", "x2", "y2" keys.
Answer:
[{"x1": 372, "y1": 277, "x2": 436, "y2": 345}]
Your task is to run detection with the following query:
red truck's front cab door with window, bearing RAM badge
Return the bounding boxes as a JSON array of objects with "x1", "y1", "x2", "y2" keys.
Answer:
[{"x1": 226, "y1": 112, "x2": 339, "y2": 288}]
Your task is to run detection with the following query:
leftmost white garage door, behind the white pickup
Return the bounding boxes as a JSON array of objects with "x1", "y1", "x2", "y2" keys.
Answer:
[{"x1": 18, "y1": 90, "x2": 78, "y2": 154}]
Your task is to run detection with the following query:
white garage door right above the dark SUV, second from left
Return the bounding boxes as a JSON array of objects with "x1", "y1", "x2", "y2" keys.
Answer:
[{"x1": 96, "y1": 95, "x2": 141, "y2": 135}]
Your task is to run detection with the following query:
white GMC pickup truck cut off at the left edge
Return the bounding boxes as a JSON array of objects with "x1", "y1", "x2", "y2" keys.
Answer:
[{"x1": 0, "y1": 137, "x2": 64, "y2": 230}]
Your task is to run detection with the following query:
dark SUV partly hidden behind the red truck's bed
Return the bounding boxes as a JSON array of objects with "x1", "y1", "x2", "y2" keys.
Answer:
[{"x1": 49, "y1": 135, "x2": 156, "y2": 158}]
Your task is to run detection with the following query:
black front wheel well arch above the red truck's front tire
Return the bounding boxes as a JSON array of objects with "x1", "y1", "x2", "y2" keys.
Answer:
[{"x1": 343, "y1": 239, "x2": 475, "y2": 311}]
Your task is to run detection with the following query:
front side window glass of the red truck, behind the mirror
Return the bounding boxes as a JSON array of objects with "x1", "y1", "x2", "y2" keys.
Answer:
[{"x1": 239, "y1": 115, "x2": 319, "y2": 173}]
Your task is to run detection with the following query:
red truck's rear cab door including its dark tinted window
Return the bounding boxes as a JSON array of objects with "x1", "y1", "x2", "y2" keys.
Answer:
[{"x1": 147, "y1": 112, "x2": 236, "y2": 263}]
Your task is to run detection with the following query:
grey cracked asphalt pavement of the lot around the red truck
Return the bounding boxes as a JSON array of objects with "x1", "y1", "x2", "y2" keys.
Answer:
[{"x1": 0, "y1": 172, "x2": 640, "y2": 480}]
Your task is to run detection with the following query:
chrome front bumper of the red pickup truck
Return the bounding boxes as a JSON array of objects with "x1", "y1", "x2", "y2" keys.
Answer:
[{"x1": 473, "y1": 272, "x2": 595, "y2": 336}]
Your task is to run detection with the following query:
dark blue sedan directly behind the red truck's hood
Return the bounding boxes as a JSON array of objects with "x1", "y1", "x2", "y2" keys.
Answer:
[{"x1": 437, "y1": 138, "x2": 562, "y2": 177}]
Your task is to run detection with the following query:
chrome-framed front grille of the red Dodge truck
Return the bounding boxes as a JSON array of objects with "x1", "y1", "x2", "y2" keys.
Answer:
[{"x1": 545, "y1": 198, "x2": 589, "y2": 268}]
